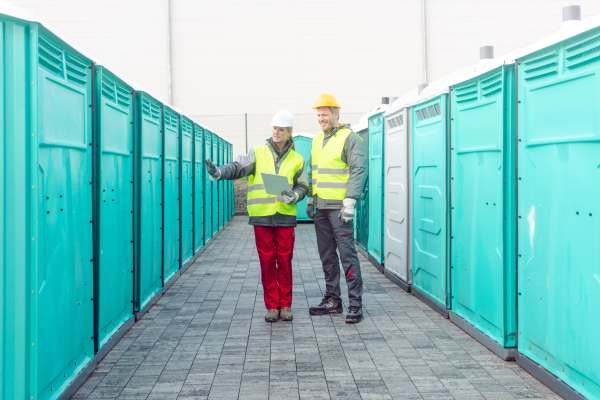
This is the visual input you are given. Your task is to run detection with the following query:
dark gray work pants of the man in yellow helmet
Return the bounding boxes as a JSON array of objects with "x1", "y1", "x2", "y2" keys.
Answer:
[{"x1": 314, "y1": 209, "x2": 362, "y2": 307}]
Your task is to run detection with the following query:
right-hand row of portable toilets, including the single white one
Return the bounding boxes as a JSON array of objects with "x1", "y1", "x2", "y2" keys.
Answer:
[{"x1": 354, "y1": 17, "x2": 600, "y2": 399}]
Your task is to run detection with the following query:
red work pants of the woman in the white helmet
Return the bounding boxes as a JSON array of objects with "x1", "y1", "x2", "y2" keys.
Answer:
[{"x1": 254, "y1": 225, "x2": 295, "y2": 310}]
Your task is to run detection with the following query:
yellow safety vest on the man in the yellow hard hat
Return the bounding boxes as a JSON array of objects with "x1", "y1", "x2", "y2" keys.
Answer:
[{"x1": 311, "y1": 128, "x2": 352, "y2": 200}]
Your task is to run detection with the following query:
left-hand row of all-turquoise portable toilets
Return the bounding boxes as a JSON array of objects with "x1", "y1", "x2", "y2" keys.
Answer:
[{"x1": 0, "y1": 11, "x2": 234, "y2": 399}]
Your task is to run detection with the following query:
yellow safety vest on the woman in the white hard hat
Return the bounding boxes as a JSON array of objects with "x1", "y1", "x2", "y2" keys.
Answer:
[{"x1": 247, "y1": 144, "x2": 304, "y2": 217}]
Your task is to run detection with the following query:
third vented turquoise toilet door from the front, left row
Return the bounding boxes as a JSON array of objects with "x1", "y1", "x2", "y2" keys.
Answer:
[{"x1": 135, "y1": 92, "x2": 163, "y2": 311}]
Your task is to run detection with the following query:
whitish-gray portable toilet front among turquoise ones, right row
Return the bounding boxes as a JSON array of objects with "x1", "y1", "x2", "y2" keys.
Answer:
[{"x1": 383, "y1": 104, "x2": 410, "y2": 290}]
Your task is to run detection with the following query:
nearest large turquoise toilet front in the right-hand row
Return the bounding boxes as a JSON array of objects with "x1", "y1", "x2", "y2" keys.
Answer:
[{"x1": 518, "y1": 29, "x2": 600, "y2": 399}]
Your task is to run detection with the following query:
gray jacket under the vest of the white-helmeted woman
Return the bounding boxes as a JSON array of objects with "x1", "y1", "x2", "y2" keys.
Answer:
[{"x1": 218, "y1": 138, "x2": 308, "y2": 226}]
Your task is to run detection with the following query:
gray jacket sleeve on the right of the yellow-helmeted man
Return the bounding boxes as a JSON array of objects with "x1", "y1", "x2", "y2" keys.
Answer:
[{"x1": 342, "y1": 132, "x2": 369, "y2": 200}]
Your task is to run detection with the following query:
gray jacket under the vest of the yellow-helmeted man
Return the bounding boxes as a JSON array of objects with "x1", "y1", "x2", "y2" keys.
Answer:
[{"x1": 311, "y1": 126, "x2": 369, "y2": 210}]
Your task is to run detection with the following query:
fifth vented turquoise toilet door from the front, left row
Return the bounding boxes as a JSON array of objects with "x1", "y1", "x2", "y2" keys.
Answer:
[{"x1": 179, "y1": 116, "x2": 194, "y2": 264}]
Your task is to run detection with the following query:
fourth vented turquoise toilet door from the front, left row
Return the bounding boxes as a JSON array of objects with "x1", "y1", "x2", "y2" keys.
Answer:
[{"x1": 163, "y1": 107, "x2": 181, "y2": 283}]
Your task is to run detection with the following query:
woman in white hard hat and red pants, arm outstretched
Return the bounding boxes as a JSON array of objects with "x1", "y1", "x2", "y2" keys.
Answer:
[{"x1": 206, "y1": 111, "x2": 309, "y2": 322}]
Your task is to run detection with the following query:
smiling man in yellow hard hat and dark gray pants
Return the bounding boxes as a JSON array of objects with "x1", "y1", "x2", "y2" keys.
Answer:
[{"x1": 308, "y1": 93, "x2": 368, "y2": 323}]
